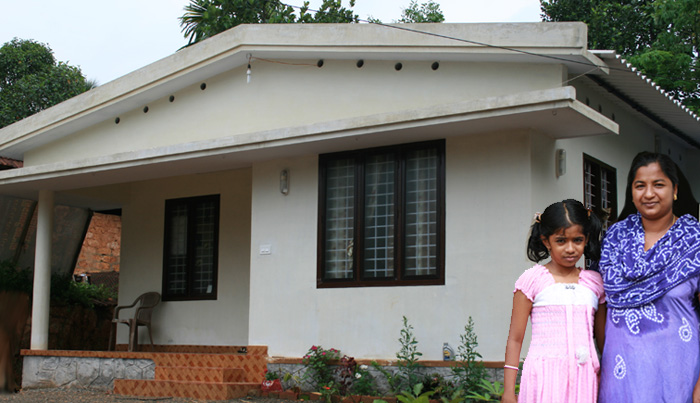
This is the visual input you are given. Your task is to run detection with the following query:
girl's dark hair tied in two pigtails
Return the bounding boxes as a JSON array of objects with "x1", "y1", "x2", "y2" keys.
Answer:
[{"x1": 527, "y1": 199, "x2": 602, "y2": 262}]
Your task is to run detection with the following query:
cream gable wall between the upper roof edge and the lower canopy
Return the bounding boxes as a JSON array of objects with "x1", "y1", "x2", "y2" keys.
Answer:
[{"x1": 24, "y1": 60, "x2": 563, "y2": 166}]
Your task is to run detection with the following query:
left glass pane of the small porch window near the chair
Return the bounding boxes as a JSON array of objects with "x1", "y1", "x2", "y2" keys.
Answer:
[{"x1": 167, "y1": 204, "x2": 187, "y2": 294}]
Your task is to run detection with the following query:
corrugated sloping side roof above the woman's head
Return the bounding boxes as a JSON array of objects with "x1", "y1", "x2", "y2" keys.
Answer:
[{"x1": 589, "y1": 50, "x2": 700, "y2": 149}]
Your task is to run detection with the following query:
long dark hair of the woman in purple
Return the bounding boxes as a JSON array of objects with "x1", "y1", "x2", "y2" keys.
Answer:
[{"x1": 617, "y1": 151, "x2": 698, "y2": 221}]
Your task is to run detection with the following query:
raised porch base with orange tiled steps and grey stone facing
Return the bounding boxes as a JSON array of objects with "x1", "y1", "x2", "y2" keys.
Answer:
[{"x1": 21, "y1": 345, "x2": 267, "y2": 400}]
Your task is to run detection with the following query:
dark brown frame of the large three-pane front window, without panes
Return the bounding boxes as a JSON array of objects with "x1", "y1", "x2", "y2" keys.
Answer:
[{"x1": 317, "y1": 140, "x2": 445, "y2": 288}]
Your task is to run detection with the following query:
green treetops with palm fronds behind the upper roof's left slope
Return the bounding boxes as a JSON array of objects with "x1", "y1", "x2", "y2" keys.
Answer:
[{"x1": 180, "y1": 0, "x2": 359, "y2": 46}]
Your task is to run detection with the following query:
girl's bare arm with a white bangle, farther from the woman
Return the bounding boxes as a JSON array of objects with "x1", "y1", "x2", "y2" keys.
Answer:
[{"x1": 501, "y1": 291, "x2": 532, "y2": 403}]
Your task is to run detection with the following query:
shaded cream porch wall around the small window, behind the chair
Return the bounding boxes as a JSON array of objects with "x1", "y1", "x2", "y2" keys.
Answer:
[{"x1": 117, "y1": 169, "x2": 251, "y2": 345}]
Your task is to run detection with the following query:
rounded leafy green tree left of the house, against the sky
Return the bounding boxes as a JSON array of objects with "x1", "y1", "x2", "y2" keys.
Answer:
[{"x1": 0, "y1": 38, "x2": 95, "y2": 128}]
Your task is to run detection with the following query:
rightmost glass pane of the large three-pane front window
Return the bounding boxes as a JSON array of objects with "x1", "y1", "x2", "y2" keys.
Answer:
[{"x1": 404, "y1": 148, "x2": 439, "y2": 276}]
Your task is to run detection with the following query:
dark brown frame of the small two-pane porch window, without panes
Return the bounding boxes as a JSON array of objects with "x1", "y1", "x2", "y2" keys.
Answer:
[{"x1": 161, "y1": 194, "x2": 221, "y2": 301}]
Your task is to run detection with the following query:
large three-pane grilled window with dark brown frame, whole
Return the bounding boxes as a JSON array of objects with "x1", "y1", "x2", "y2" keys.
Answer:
[{"x1": 318, "y1": 141, "x2": 445, "y2": 287}]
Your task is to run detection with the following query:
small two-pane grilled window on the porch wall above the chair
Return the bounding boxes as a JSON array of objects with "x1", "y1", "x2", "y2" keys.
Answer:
[{"x1": 162, "y1": 195, "x2": 219, "y2": 301}]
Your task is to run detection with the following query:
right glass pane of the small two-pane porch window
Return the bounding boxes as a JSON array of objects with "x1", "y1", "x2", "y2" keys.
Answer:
[{"x1": 192, "y1": 201, "x2": 217, "y2": 294}]
